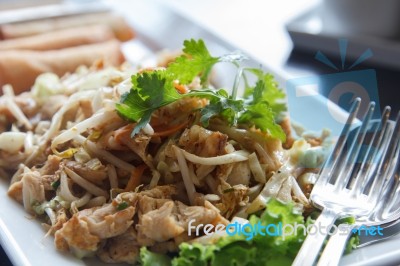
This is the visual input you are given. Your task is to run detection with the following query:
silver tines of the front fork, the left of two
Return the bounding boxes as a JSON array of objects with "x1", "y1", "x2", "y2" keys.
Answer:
[{"x1": 318, "y1": 98, "x2": 400, "y2": 200}]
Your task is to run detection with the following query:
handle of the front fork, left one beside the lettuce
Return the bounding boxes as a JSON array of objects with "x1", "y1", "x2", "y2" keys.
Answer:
[{"x1": 292, "y1": 208, "x2": 338, "y2": 266}]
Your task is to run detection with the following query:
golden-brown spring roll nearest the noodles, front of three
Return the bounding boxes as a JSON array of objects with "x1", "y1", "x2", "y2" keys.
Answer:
[{"x1": 0, "y1": 40, "x2": 125, "y2": 93}]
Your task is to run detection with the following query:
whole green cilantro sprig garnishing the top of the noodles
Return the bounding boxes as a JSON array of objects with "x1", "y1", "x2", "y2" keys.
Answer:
[{"x1": 116, "y1": 39, "x2": 286, "y2": 141}]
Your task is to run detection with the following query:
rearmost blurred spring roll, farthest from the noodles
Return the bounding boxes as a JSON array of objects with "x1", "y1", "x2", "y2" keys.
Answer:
[{"x1": 0, "y1": 12, "x2": 135, "y2": 41}]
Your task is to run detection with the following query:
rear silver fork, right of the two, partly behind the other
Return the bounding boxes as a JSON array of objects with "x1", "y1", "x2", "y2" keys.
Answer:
[{"x1": 318, "y1": 108, "x2": 400, "y2": 266}]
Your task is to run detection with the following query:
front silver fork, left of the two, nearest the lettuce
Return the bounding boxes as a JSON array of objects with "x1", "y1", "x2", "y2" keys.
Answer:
[{"x1": 292, "y1": 98, "x2": 388, "y2": 266}]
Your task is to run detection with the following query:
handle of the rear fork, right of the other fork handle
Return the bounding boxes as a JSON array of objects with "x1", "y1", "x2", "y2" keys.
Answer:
[{"x1": 317, "y1": 225, "x2": 355, "y2": 266}]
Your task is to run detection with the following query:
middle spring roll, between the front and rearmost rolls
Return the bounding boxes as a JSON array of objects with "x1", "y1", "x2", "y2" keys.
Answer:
[{"x1": 0, "y1": 25, "x2": 114, "y2": 51}]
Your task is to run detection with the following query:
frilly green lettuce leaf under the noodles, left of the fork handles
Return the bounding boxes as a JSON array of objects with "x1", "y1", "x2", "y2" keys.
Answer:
[{"x1": 172, "y1": 199, "x2": 305, "y2": 266}]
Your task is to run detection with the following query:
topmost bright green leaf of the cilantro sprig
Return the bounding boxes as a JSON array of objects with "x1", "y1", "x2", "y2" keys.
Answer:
[{"x1": 167, "y1": 39, "x2": 219, "y2": 84}]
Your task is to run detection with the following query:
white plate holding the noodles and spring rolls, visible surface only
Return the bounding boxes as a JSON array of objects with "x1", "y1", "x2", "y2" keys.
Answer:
[{"x1": 0, "y1": 1, "x2": 400, "y2": 266}]
